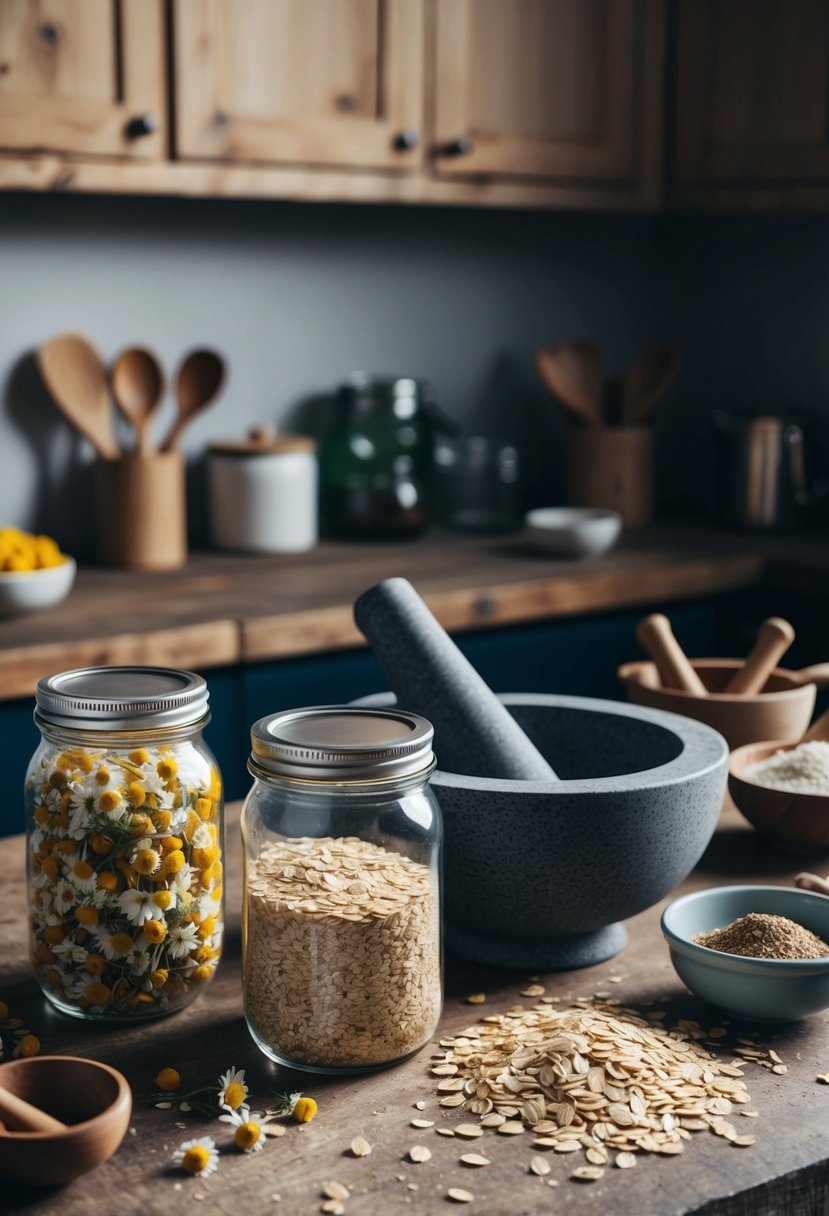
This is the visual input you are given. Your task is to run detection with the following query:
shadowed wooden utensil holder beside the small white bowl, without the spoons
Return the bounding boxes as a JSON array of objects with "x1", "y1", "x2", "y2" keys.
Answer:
[{"x1": 566, "y1": 427, "x2": 654, "y2": 528}]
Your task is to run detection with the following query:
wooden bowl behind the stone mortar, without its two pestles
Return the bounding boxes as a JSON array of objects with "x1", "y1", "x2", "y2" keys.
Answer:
[{"x1": 616, "y1": 659, "x2": 829, "y2": 748}]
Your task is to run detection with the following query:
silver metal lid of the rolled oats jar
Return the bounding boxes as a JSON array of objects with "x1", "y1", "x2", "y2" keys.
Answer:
[{"x1": 250, "y1": 705, "x2": 434, "y2": 781}]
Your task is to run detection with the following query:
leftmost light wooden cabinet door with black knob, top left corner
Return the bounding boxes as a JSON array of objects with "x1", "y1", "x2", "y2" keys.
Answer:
[{"x1": 0, "y1": 0, "x2": 165, "y2": 159}]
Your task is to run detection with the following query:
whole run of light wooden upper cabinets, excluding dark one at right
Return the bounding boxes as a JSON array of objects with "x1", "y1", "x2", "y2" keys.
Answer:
[{"x1": 0, "y1": 0, "x2": 665, "y2": 209}]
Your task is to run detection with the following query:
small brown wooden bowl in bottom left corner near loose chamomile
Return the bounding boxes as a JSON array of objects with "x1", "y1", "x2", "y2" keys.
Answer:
[{"x1": 0, "y1": 1055, "x2": 132, "y2": 1186}]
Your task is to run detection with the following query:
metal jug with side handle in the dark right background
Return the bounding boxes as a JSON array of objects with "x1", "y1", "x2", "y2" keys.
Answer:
[{"x1": 711, "y1": 411, "x2": 810, "y2": 531}]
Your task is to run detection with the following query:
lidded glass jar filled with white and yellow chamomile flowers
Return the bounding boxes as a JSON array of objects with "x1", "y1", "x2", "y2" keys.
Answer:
[{"x1": 26, "y1": 666, "x2": 224, "y2": 1021}]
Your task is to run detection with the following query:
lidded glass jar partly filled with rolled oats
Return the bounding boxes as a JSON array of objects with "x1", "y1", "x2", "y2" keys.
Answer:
[{"x1": 242, "y1": 705, "x2": 442, "y2": 1073}]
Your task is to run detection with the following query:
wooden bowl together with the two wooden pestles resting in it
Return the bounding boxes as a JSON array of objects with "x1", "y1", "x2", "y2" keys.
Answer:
[{"x1": 617, "y1": 614, "x2": 829, "y2": 748}]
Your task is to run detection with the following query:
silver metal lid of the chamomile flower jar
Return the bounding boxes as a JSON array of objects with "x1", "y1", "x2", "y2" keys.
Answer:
[{"x1": 35, "y1": 666, "x2": 208, "y2": 731}]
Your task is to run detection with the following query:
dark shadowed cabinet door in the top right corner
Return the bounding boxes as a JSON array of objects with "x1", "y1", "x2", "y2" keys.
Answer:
[{"x1": 676, "y1": 0, "x2": 829, "y2": 187}]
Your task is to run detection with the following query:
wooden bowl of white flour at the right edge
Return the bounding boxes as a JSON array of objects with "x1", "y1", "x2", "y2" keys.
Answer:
[{"x1": 728, "y1": 739, "x2": 829, "y2": 855}]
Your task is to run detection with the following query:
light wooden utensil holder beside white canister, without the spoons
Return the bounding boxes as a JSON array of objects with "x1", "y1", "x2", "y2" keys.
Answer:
[{"x1": 95, "y1": 451, "x2": 187, "y2": 570}]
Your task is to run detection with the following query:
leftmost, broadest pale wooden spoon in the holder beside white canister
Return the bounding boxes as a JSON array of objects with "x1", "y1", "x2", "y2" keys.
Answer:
[{"x1": 38, "y1": 333, "x2": 119, "y2": 460}]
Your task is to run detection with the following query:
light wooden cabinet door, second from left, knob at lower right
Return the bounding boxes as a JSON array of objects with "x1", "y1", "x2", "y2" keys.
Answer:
[{"x1": 174, "y1": 0, "x2": 424, "y2": 169}]
